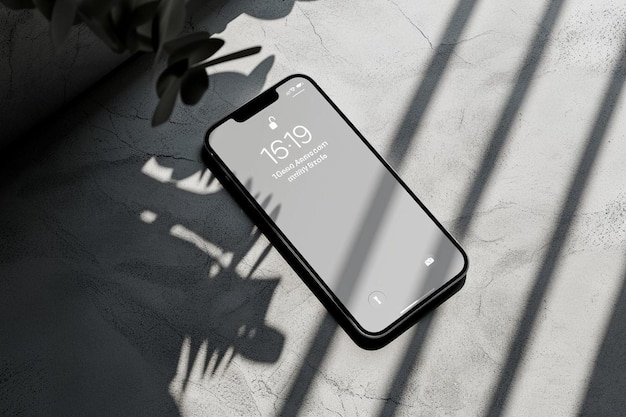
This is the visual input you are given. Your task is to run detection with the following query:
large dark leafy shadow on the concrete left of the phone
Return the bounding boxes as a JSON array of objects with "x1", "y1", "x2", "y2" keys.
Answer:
[{"x1": 0, "y1": 39, "x2": 284, "y2": 416}]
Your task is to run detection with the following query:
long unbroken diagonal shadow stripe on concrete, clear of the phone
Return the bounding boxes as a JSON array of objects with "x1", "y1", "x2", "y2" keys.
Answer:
[{"x1": 486, "y1": 35, "x2": 626, "y2": 417}]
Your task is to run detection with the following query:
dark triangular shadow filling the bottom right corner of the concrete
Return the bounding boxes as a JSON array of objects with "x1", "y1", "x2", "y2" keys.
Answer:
[{"x1": 578, "y1": 262, "x2": 626, "y2": 417}]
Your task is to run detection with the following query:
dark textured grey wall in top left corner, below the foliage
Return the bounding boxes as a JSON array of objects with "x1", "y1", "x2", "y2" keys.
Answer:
[{"x1": 0, "y1": 5, "x2": 128, "y2": 149}]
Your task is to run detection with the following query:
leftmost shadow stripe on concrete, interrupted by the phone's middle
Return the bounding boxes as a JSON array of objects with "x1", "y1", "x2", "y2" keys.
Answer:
[{"x1": 279, "y1": 0, "x2": 477, "y2": 415}]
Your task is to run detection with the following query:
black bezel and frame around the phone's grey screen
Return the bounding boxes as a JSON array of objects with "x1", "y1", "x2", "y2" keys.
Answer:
[{"x1": 204, "y1": 74, "x2": 469, "y2": 349}]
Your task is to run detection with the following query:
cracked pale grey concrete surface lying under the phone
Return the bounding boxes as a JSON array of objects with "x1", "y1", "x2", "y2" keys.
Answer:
[{"x1": 0, "y1": 0, "x2": 626, "y2": 416}]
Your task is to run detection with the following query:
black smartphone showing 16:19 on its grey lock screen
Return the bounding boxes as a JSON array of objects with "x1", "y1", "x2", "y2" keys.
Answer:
[{"x1": 205, "y1": 75, "x2": 468, "y2": 349}]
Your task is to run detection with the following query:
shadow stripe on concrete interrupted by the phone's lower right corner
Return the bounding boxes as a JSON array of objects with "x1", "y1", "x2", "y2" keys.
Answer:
[{"x1": 379, "y1": 0, "x2": 564, "y2": 416}]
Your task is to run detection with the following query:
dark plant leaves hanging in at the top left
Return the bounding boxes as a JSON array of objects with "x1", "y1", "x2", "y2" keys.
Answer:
[{"x1": 0, "y1": 0, "x2": 261, "y2": 126}]
